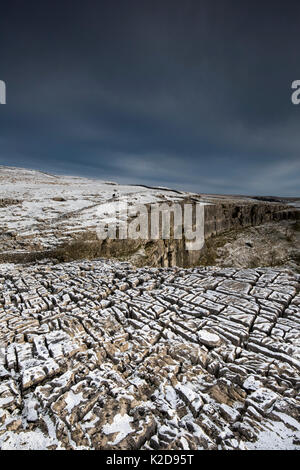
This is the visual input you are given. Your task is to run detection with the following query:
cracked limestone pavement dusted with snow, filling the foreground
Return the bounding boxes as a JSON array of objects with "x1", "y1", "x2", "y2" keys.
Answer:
[{"x1": 0, "y1": 260, "x2": 300, "y2": 450}]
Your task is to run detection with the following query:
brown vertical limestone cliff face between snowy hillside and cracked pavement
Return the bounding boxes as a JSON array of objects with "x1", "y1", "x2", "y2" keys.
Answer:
[{"x1": 71, "y1": 202, "x2": 300, "y2": 267}]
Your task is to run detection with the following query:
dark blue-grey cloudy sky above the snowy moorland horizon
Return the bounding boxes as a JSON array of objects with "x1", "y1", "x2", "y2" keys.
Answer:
[{"x1": 0, "y1": 0, "x2": 300, "y2": 195}]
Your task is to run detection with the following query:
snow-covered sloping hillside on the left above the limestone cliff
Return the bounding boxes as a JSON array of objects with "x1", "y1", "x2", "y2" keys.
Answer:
[{"x1": 0, "y1": 166, "x2": 196, "y2": 252}]
